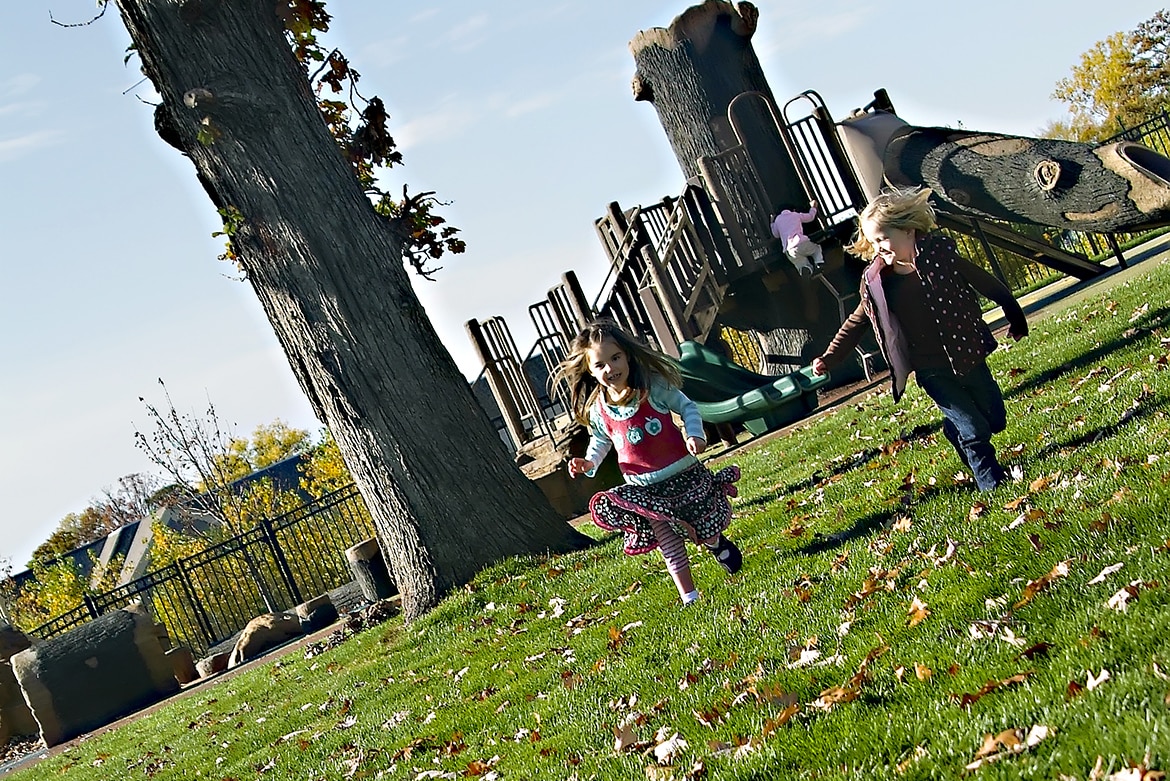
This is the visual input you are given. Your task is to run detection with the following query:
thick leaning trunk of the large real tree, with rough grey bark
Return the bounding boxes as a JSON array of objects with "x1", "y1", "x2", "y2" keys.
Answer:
[{"x1": 117, "y1": 0, "x2": 587, "y2": 620}]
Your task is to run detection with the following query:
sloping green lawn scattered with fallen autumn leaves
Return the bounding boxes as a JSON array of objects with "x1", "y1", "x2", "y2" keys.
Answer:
[{"x1": 15, "y1": 261, "x2": 1170, "y2": 781}]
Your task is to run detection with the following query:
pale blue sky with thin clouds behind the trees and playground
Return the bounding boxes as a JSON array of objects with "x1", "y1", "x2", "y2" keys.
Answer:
[{"x1": 0, "y1": 0, "x2": 1161, "y2": 569}]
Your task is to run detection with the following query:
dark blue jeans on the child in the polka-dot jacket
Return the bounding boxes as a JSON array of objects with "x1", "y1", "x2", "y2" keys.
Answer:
[{"x1": 915, "y1": 364, "x2": 1007, "y2": 491}]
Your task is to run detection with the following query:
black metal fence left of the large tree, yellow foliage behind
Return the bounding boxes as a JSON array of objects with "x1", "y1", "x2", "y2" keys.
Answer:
[{"x1": 30, "y1": 485, "x2": 374, "y2": 655}]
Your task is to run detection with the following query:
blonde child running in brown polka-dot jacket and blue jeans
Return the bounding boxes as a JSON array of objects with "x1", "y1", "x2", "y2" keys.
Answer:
[{"x1": 812, "y1": 187, "x2": 1027, "y2": 491}]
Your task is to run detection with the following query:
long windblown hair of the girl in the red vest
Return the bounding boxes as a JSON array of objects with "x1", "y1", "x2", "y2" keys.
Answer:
[{"x1": 549, "y1": 320, "x2": 682, "y2": 426}]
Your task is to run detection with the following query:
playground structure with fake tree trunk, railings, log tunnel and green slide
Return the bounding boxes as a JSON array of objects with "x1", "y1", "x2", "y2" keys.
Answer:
[{"x1": 467, "y1": 0, "x2": 1170, "y2": 514}]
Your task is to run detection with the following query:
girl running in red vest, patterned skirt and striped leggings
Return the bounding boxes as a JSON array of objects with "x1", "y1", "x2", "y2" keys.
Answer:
[{"x1": 553, "y1": 320, "x2": 743, "y2": 604}]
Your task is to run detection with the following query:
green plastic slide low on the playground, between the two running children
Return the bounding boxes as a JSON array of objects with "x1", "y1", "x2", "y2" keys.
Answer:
[{"x1": 679, "y1": 341, "x2": 828, "y2": 436}]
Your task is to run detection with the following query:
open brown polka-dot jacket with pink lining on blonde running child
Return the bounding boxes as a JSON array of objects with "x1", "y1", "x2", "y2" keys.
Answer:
[{"x1": 821, "y1": 231, "x2": 1027, "y2": 401}]
